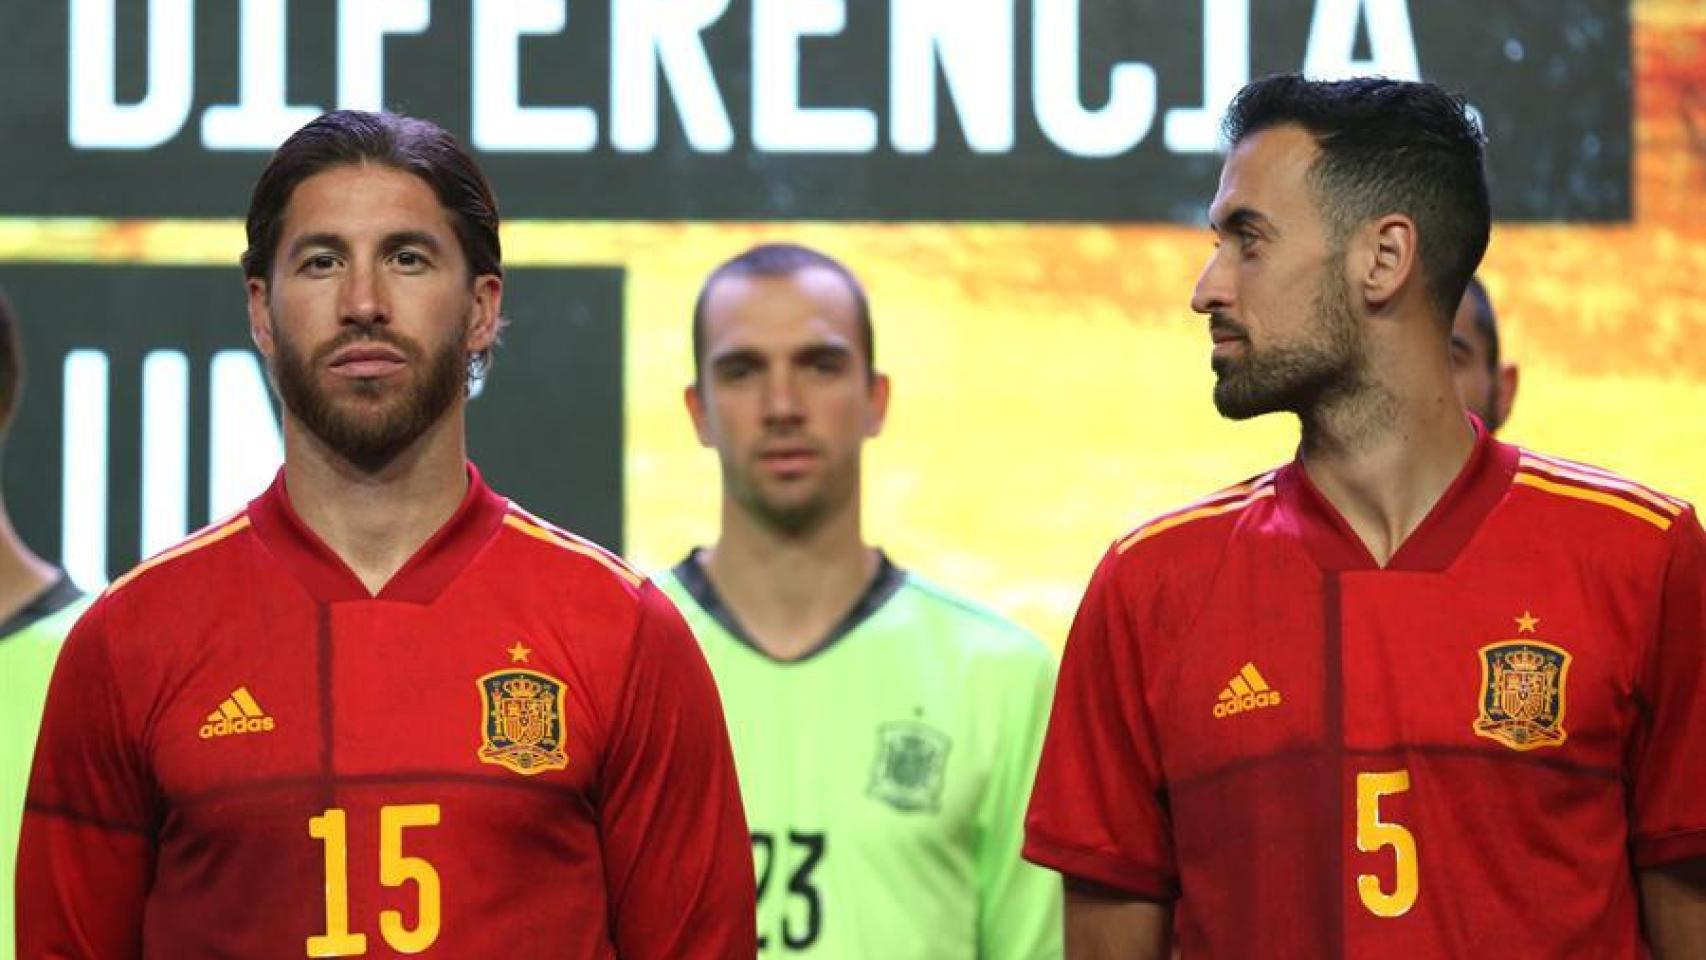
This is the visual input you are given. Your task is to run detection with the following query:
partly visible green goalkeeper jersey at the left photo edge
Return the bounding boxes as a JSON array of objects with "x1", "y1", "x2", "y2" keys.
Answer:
[{"x1": 0, "y1": 575, "x2": 89, "y2": 960}]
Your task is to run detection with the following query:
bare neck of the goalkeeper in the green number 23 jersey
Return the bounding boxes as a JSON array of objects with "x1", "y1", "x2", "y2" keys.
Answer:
[{"x1": 699, "y1": 494, "x2": 879, "y2": 660}]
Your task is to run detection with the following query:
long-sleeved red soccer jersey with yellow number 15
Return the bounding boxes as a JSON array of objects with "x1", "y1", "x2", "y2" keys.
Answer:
[{"x1": 17, "y1": 469, "x2": 756, "y2": 960}]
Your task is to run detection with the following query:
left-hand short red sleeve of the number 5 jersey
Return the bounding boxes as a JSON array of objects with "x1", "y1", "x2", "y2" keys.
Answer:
[{"x1": 1025, "y1": 549, "x2": 1177, "y2": 900}]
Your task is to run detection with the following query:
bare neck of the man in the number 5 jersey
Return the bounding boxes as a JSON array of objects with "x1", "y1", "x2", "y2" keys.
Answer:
[{"x1": 1298, "y1": 352, "x2": 1474, "y2": 566}]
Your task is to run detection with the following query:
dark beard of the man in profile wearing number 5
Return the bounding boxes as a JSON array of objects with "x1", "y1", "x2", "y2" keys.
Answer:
[{"x1": 1213, "y1": 276, "x2": 1361, "y2": 419}]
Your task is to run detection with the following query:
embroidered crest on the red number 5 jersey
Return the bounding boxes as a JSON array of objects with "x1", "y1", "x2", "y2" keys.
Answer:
[{"x1": 1474, "y1": 639, "x2": 1570, "y2": 750}]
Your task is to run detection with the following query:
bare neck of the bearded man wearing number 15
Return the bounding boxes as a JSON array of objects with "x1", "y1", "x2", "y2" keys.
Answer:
[{"x1": 285, "y1": 404, "x2": 467, "y2": 593}]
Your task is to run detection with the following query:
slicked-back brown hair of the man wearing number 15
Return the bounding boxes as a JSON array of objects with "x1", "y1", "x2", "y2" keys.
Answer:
[{"x1": 242, "y1": 111, "x2": 503, "y2": 380}]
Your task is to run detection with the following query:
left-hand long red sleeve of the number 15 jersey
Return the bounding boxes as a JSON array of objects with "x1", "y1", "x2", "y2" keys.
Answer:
[{"x1": 17, "y1": 604, "x2": 155, "y2": 960}]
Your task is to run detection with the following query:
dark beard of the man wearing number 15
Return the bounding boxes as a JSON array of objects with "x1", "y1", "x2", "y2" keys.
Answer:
[{"x1": 270, "y1": 322, "x2": 467, "y2": 474}]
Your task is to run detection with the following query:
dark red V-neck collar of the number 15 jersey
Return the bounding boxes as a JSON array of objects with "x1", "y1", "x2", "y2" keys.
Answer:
[{"x1": 249, "y1": 464, "x2": 508, "y2": 604}]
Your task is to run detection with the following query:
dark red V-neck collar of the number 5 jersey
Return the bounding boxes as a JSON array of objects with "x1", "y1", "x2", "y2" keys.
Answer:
[{"x1": 1274, "y1": 414, "x2": 1518, "y2": 571}]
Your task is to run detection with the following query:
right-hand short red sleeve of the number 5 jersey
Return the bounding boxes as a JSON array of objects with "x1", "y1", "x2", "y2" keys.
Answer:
[{"x1": 1631, "y1": 510, "x2": 1706, "y2": 866}]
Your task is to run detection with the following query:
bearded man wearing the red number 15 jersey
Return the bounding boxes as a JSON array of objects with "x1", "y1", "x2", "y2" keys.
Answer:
[{"x1": 19, "y1": 111, "x2": 754, "y2": 960}]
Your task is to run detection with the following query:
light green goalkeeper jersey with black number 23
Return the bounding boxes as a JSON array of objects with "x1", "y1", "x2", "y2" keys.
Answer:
[{"x1": 655, "y1": 554, "x2": 1061, "y2": 960}]
